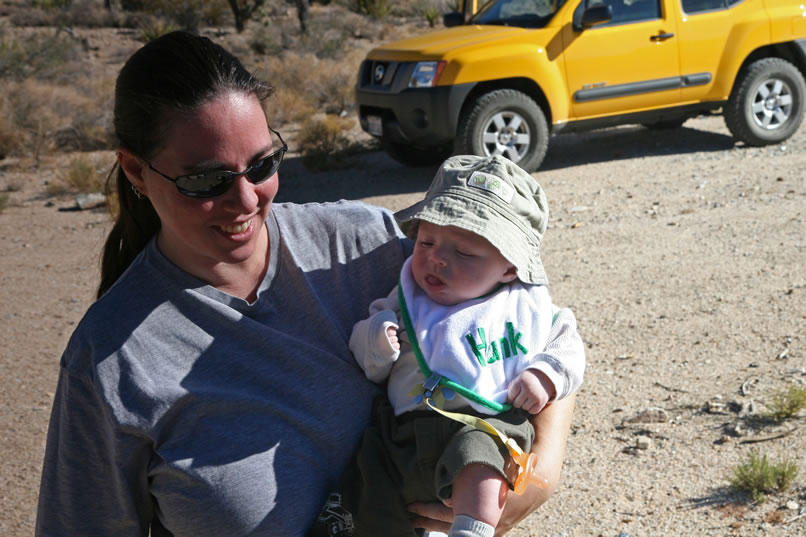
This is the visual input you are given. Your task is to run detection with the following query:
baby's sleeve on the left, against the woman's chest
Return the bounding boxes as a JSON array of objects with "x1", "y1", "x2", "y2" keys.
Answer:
[{"x1": 350, "y1": 286, "x2": 400, "y2": 383}]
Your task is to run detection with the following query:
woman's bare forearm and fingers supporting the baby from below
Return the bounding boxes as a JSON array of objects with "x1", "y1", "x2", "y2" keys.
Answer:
[{"x1": 409, "y1": 395, "x2": 576, "y2": 537}]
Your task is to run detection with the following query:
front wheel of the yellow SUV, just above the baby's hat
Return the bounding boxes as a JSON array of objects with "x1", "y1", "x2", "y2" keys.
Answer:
[{"x1": 454, "y1": 89, "x2": 549, "y2": 172}]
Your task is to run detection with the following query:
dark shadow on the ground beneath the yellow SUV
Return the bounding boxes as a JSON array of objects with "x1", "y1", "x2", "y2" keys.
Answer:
[{"x1": 277, "y1": 120, "x2": 735, "y2": 203}]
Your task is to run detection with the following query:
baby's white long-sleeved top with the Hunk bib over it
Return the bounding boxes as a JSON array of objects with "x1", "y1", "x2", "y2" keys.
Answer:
[{"x1": 350, "y1": 260, "x2": 585, "y2": 415}]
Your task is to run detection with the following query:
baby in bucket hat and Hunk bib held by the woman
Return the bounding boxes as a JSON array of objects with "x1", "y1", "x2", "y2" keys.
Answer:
[{"x1": 312, "y1": 156, "x2": 585, "y2": 537}]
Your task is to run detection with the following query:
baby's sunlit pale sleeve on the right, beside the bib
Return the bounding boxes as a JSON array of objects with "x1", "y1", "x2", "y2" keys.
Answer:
[{"x1": 529, "y1": 307, "x2": 586, "y2": 400}]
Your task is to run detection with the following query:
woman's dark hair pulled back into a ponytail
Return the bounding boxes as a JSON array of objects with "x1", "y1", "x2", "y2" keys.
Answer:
[{"x1": 97, "y1": 32, "x2": 272, "y2": 298}]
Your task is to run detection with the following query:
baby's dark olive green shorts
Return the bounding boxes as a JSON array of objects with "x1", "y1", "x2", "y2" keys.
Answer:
[{"x1": 309, "y1": 398, "x2": 534, "y2": 537}]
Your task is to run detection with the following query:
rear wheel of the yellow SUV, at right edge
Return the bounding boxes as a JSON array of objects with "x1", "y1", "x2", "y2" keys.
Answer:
[{"x1": 724, "y1": 58, "x2": 806, "y2": 146}]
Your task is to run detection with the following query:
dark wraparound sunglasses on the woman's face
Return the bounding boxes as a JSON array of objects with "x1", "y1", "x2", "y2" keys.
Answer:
[{"x1": 145, "y1": 127, "x2": 288, "y2": 198}]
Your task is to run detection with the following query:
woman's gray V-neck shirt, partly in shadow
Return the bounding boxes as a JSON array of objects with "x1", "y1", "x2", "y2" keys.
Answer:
[{"x1": 36, "y1": 202, "x2": 410, "y2": 537}]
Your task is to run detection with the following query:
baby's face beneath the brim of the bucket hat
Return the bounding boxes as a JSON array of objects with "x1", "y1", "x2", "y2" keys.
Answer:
[{"x1": 411, "y1": 222, "x2": 516, "y2": 306}]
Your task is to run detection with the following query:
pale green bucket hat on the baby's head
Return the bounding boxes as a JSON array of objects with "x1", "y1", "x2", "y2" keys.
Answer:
[{"x1": 395, "y1": 155, "x2": 549, "y2": 284}]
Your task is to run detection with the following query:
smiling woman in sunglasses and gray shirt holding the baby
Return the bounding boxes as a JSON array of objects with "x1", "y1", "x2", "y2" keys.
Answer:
[{"x1": 36, "y1": 32, "x2": 572, "y2": 537}]
